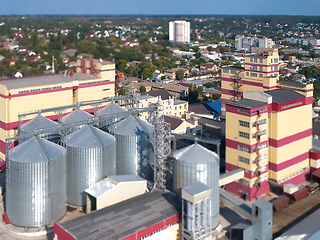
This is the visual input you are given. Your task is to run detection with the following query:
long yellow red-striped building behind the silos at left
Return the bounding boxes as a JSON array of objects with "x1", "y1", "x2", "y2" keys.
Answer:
[{"x1": 0, "y1": 59, "x2": 115, "y2": 160}]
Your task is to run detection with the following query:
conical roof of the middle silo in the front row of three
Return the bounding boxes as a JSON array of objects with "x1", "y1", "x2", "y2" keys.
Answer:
[{"x1": 65, "y1": 125, "x2": 116, "y2": 148}]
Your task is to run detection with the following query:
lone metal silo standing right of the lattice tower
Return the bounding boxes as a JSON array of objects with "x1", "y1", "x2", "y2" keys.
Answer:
[{"x1": 173, "y1": 143, "x2": 219, "y2": 229}]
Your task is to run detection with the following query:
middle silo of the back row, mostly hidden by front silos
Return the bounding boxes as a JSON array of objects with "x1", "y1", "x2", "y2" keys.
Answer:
[{"x1": 61, "y1": 108, "x2": 94, "y2": 135}]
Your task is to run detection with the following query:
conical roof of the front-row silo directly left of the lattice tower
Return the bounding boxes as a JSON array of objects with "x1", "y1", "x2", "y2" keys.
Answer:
[{"x1": 114, "y1": 116, "x2": 154, "y2": 136}]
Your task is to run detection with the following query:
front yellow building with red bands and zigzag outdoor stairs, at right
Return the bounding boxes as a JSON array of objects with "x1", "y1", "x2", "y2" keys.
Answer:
[{"x1": 226, "y1": 89, "x2": 312, "y2": 201}]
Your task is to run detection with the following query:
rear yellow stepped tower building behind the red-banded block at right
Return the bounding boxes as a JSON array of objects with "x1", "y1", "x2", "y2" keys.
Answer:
[{"x1": 221, "y1": 48, "x2": 313, "y2": 116}]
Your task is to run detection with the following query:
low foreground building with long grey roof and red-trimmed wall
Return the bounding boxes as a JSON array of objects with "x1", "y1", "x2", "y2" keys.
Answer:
[{"x1": 53, "y1": 190, "x2": 181, "y2": 240}]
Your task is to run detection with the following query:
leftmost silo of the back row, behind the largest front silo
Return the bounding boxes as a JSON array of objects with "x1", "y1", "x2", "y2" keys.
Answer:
[{"x1": 19, "y1": 115, "x2": 61, "y2": 143}]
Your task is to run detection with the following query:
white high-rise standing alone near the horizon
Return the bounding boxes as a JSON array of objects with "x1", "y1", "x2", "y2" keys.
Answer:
[{"x1": 169, "y1": 21, "x2": 190, "y2": 43}]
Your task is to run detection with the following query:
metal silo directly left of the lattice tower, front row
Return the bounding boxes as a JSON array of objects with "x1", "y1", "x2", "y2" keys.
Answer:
[{"x1": 114, "y1": 116, "x2": 154, "y2": 180}]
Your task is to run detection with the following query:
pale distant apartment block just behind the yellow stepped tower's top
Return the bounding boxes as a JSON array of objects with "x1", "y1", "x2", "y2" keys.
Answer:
[{"x1": 235, "y1": 35, "x2": 274, "y2": 50}]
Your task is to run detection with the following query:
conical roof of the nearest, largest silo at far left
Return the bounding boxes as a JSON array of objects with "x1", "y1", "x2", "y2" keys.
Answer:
[{"x1": 8, "y1": 137, "x2": 66, "y2": 163}]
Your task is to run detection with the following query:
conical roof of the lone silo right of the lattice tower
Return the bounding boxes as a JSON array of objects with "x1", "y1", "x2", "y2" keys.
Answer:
[{"x1": 173, "y1": 143, "x2": 219, "y2": 164}]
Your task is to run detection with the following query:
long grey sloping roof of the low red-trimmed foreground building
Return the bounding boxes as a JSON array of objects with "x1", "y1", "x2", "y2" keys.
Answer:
[{"x1": 61, "y1": 190, "x2": 181, "y2": 240}]
